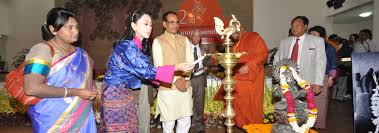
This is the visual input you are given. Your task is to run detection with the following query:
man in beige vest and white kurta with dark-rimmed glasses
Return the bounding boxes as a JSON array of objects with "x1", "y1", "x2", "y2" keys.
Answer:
[{"x1": 153, "y1": 12, "x2": 194, "y2": 133}]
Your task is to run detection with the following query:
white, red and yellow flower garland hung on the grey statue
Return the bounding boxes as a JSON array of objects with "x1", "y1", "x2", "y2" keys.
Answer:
[{"x1": 279, "y1": 65, "x2": 317, "y2": 133}]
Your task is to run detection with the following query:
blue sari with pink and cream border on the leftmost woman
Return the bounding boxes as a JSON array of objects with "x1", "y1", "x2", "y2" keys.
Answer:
[{"x1": 24, "y1": 48, "x2": 97, "y2": 133}]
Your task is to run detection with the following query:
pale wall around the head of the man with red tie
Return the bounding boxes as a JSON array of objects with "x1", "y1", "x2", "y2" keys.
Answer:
[{"x1": 253, "y1": 0, "x2": 332, "y2": 48}]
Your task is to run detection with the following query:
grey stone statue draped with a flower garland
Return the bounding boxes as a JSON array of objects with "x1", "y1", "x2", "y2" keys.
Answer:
[{"x1": 272, "y1": 59, "x2": 317, "y2": 133}]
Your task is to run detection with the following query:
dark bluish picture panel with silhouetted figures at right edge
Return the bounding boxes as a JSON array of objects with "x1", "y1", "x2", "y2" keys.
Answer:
[{"x1": 352, "y1": 52, "x2": 379, "y2": 133}]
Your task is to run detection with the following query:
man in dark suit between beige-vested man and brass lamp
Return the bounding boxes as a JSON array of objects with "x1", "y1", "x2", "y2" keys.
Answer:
[{"x1": 190, "y1": 29, "x2": 210, "y2": 133}]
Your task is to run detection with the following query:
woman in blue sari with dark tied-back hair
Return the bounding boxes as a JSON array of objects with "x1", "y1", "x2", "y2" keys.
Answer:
[{"x1": 24, "y1": 8, "x2": 100, "y2": 133}]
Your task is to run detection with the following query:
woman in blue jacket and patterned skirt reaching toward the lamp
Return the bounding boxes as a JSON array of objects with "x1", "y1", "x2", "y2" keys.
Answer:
[{"x1": 101, "y1": 11, "x2": 194, "y2": 133}]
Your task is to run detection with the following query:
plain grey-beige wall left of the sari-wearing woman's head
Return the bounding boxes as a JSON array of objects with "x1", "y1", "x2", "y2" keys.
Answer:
[{"x1": 5, "y1": 0, "x2": 54, "y2": 69}]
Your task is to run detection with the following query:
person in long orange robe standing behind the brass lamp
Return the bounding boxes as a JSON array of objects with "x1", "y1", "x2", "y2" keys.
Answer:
[{"x1": 215, "y1": 31, "x2": 268, "y2": 128}]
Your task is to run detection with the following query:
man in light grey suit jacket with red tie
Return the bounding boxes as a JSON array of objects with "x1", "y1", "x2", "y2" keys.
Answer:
[{"x1": 274, "y1": 16, "x2": 326, "y2": 95}]
